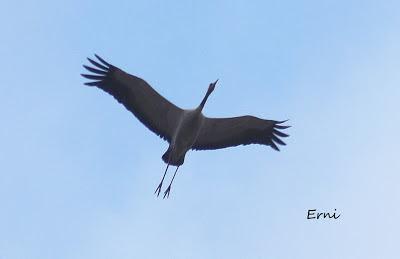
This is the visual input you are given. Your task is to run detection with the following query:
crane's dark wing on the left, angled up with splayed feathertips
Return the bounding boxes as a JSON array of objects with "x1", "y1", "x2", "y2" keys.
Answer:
[{"x1": 82, "y1": 55, "x2": 183, "y2": 142}]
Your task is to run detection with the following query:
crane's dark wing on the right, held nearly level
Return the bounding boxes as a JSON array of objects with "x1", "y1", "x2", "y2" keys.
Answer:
[{"x1": 192, "y1": 116, "x2": 290, "y2": 151}]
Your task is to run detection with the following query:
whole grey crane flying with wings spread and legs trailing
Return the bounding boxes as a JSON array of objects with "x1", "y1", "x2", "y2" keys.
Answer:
[{"x1": 81, "y1": 55, "x2": 290, "y2": 198}]
